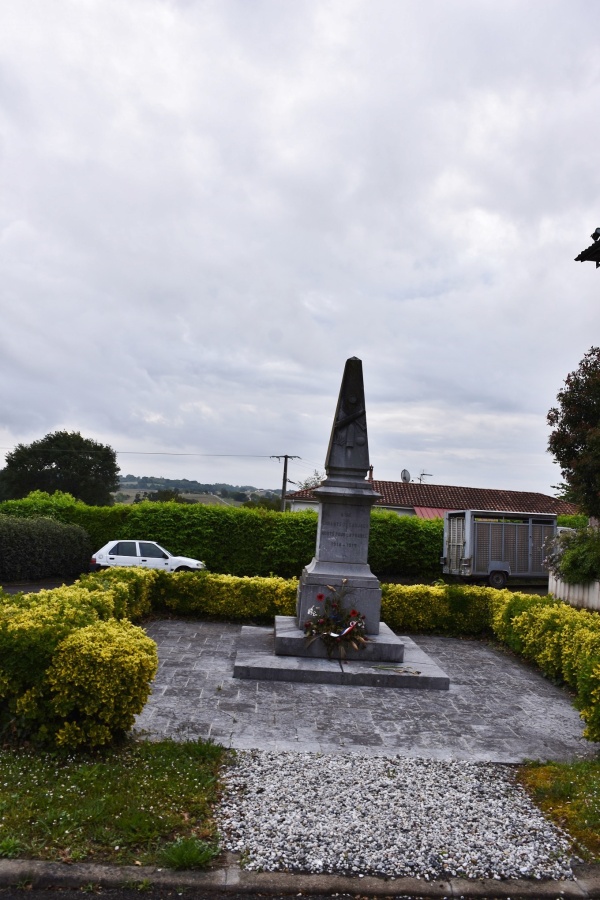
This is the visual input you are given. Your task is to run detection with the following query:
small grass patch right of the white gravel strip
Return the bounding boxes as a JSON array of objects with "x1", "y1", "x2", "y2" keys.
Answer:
[{"x1": 519, "y1": 761, "x2": 600, "y2": 862}]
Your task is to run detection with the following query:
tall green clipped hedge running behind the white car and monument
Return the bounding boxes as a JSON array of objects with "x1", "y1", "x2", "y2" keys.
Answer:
[{"x1": 0, "y1": 491, "x2": 443, "y2": 580}]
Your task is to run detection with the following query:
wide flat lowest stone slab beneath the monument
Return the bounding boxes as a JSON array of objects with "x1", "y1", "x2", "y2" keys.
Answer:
[{"x1": 233, "y1": 616, "x2": 449, "y2": 691}]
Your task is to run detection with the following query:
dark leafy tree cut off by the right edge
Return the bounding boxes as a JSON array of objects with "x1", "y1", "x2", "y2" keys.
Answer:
[{"x1": 548, "y1": 347, "x2": 600, "y2": 517}]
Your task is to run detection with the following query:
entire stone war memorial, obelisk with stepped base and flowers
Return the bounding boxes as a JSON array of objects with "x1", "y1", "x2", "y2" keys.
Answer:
[{"x1": 234, "y1": 357, "x2": 449, "y2": 690}]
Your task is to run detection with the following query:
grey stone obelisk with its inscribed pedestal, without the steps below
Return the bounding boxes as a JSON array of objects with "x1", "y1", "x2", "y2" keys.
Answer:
[{"x1": 296, "y1": 356, "x2": 381, "y2": 635}]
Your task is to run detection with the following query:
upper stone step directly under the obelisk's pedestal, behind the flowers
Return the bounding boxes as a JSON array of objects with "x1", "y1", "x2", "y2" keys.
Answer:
[{"x1": 275, "y1": 616, "x2": 404, "y2": 662}]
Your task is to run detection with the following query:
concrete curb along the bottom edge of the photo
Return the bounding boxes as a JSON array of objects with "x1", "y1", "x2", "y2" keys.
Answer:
[{"x1": 0, "y1": 859, "x2": 600, "y2": 900}]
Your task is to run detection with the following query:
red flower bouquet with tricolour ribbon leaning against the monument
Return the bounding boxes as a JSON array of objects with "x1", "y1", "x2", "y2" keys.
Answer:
[{"x1": 304, "y1": 578, "x2": 367, "y2": 659}]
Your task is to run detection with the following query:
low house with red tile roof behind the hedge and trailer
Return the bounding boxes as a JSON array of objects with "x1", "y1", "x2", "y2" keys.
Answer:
[{"x1": 286, "y1": 479, "x2": 579, "y2": 519}]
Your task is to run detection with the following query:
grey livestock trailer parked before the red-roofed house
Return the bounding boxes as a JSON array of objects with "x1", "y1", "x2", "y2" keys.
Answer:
[{"x1": 440, "y1": 509, "x2": 556, "y2": 588}]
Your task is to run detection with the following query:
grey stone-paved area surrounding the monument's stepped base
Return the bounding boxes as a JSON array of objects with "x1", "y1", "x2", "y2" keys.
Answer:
[{"x1": 136, "y1": 620, "x2": 600, "y2": 763}]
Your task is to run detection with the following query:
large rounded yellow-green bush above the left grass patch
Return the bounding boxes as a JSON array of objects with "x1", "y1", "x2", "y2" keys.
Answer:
[{"x1": 0, "y1": 570, "x2": 158, "y2": 747}]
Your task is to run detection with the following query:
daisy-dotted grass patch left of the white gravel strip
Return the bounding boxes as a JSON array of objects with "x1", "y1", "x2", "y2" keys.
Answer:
[{"x1": 0, "y1": 740, "x2": 225, "y2": 868}]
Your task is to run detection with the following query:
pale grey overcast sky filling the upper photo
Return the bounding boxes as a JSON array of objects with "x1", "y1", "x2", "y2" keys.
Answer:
[{"x1": 0, "y1": 0, "x2": 600, "y2": 493}]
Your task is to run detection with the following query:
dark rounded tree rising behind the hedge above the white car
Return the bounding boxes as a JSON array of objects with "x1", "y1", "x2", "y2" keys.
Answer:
[{"x1": 0, "y1": 431, "x2": 119, "y2": 506}]
